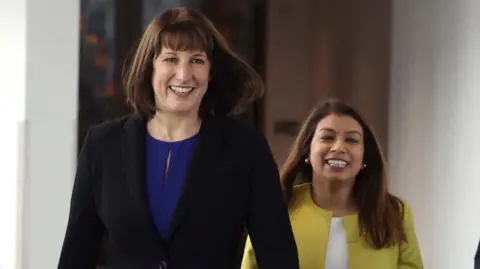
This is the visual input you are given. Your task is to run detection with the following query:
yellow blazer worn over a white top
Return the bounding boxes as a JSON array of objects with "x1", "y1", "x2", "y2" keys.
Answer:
[{"x1": 241, "y1": 183, "x2": 423, "y2": 269}]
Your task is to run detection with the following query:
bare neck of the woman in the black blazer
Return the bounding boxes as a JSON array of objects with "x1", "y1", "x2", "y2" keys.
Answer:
[{"x1": 147, "y1": 111, "x2": 202, "y2": 141}]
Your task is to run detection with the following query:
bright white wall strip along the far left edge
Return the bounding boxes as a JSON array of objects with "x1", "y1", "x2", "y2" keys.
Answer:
[{"x1": 0, "y1": 0, "x2": 26, "y2": 269}]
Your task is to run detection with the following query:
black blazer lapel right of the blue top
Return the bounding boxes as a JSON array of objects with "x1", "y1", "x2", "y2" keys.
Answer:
[{"x1": 168, "y1": 118, "x2": 224, "y2": 239}]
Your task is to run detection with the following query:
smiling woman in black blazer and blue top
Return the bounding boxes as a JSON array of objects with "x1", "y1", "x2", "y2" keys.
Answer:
[{"x1": 58, "y1": 5, "x2": 298, "y2": 269}]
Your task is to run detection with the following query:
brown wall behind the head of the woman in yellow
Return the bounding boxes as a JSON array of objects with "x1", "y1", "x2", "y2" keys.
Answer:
[{"x1": 265, "y1": 0, "x2": 391, "y2": 165}]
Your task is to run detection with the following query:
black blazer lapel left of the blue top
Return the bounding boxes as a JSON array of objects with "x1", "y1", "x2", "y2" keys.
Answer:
[{"x1": 122, "y1": 114, "x2": 162, "y2": 246}]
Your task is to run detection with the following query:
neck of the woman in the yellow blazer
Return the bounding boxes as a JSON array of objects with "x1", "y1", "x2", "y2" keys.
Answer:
[{"x1": 312, "y1": 176, "x2": 356, "y2": 217}]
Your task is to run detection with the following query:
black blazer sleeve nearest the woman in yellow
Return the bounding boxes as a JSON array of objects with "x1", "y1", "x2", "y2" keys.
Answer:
[{"x1": 247, "y1": 135, "x2": 299, "y2": 269}]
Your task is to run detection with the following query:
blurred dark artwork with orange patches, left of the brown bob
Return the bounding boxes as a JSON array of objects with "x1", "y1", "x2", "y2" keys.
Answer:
[{"x1": 78, "y1": 0, "x2": 123, "y2": 147}]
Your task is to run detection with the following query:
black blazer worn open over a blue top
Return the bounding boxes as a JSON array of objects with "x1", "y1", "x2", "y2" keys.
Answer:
[{"x1": 58, "y1": 114, "x2": 299, "y2": 269}]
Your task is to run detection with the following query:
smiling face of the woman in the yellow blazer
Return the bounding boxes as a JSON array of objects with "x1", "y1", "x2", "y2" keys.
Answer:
[{"x1": 309, "y1": 114, "x2": 364, "y2": 180}]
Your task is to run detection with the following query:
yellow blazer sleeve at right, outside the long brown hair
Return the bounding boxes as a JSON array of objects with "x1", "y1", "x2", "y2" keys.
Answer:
[{"x1": 397, "y1": 203, "x2": 423, "y2": 269}]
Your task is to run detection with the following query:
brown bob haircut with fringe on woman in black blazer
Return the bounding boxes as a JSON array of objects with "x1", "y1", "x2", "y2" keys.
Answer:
[{"x1": 123, "y1": 8, "x2": 264, "y2": 119}]
